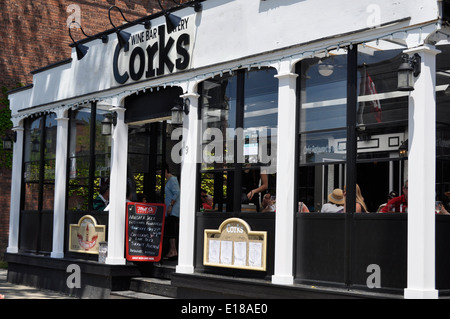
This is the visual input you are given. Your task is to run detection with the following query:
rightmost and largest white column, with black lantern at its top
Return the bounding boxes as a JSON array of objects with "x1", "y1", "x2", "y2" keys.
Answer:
[{"x1": 404, "y1": 45, "x2": 439, "y2": 299}]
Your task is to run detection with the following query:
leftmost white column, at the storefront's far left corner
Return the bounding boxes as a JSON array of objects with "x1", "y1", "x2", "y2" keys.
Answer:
[{"x1": 6, "y1": 126, "x2": 24, "y2": 254}]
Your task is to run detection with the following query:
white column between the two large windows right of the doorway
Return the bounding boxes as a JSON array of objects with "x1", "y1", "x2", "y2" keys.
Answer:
[{"x1": 272, "y1": 72, "x2": 298, "y2": 285}]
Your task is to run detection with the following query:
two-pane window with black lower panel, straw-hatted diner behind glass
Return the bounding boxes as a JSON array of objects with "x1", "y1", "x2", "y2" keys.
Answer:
[{"x1": 295, "y1": 40, "x2": 408, "y2": 290}]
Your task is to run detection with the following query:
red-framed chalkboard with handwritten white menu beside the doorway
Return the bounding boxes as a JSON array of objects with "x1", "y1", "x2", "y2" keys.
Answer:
[{"x1": 126, "y1": 202, "x2": 166, "y2": 262}]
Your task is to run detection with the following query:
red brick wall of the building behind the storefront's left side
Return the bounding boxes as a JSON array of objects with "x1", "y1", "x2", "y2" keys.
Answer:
[{"x1": 0, "y1": 0, "x2": 186, "y2": 260}]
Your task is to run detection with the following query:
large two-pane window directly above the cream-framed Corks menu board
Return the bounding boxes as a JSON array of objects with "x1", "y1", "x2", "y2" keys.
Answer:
[{"x1": 199, "y1": 69, "x2": 278, "y2": 212}]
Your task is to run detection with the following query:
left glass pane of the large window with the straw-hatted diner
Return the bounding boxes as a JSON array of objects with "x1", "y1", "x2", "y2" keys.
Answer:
[{"x1": 297, "y1": 50, "x2": 347, "y2": 212}]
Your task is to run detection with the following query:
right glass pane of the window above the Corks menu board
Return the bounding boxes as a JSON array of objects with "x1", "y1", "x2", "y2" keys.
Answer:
[{"x1": 238, "y1": 69, "x2": 278, "y2": 212}]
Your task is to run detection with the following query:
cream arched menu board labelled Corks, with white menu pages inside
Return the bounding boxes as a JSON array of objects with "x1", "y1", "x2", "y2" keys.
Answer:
[{"x1": 203, "y1": 218, "x2": 267, "y2": 271}]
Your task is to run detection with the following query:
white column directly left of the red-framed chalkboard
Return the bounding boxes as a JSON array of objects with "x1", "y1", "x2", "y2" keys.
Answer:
[{"x1": 106, "y1": 107, "x2": 128, "y2": 265}]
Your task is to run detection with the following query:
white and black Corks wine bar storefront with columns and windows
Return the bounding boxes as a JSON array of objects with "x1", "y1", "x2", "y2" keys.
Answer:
[{"x1": 7, "y1": 0, "x2": 450, "y2": 298}]
